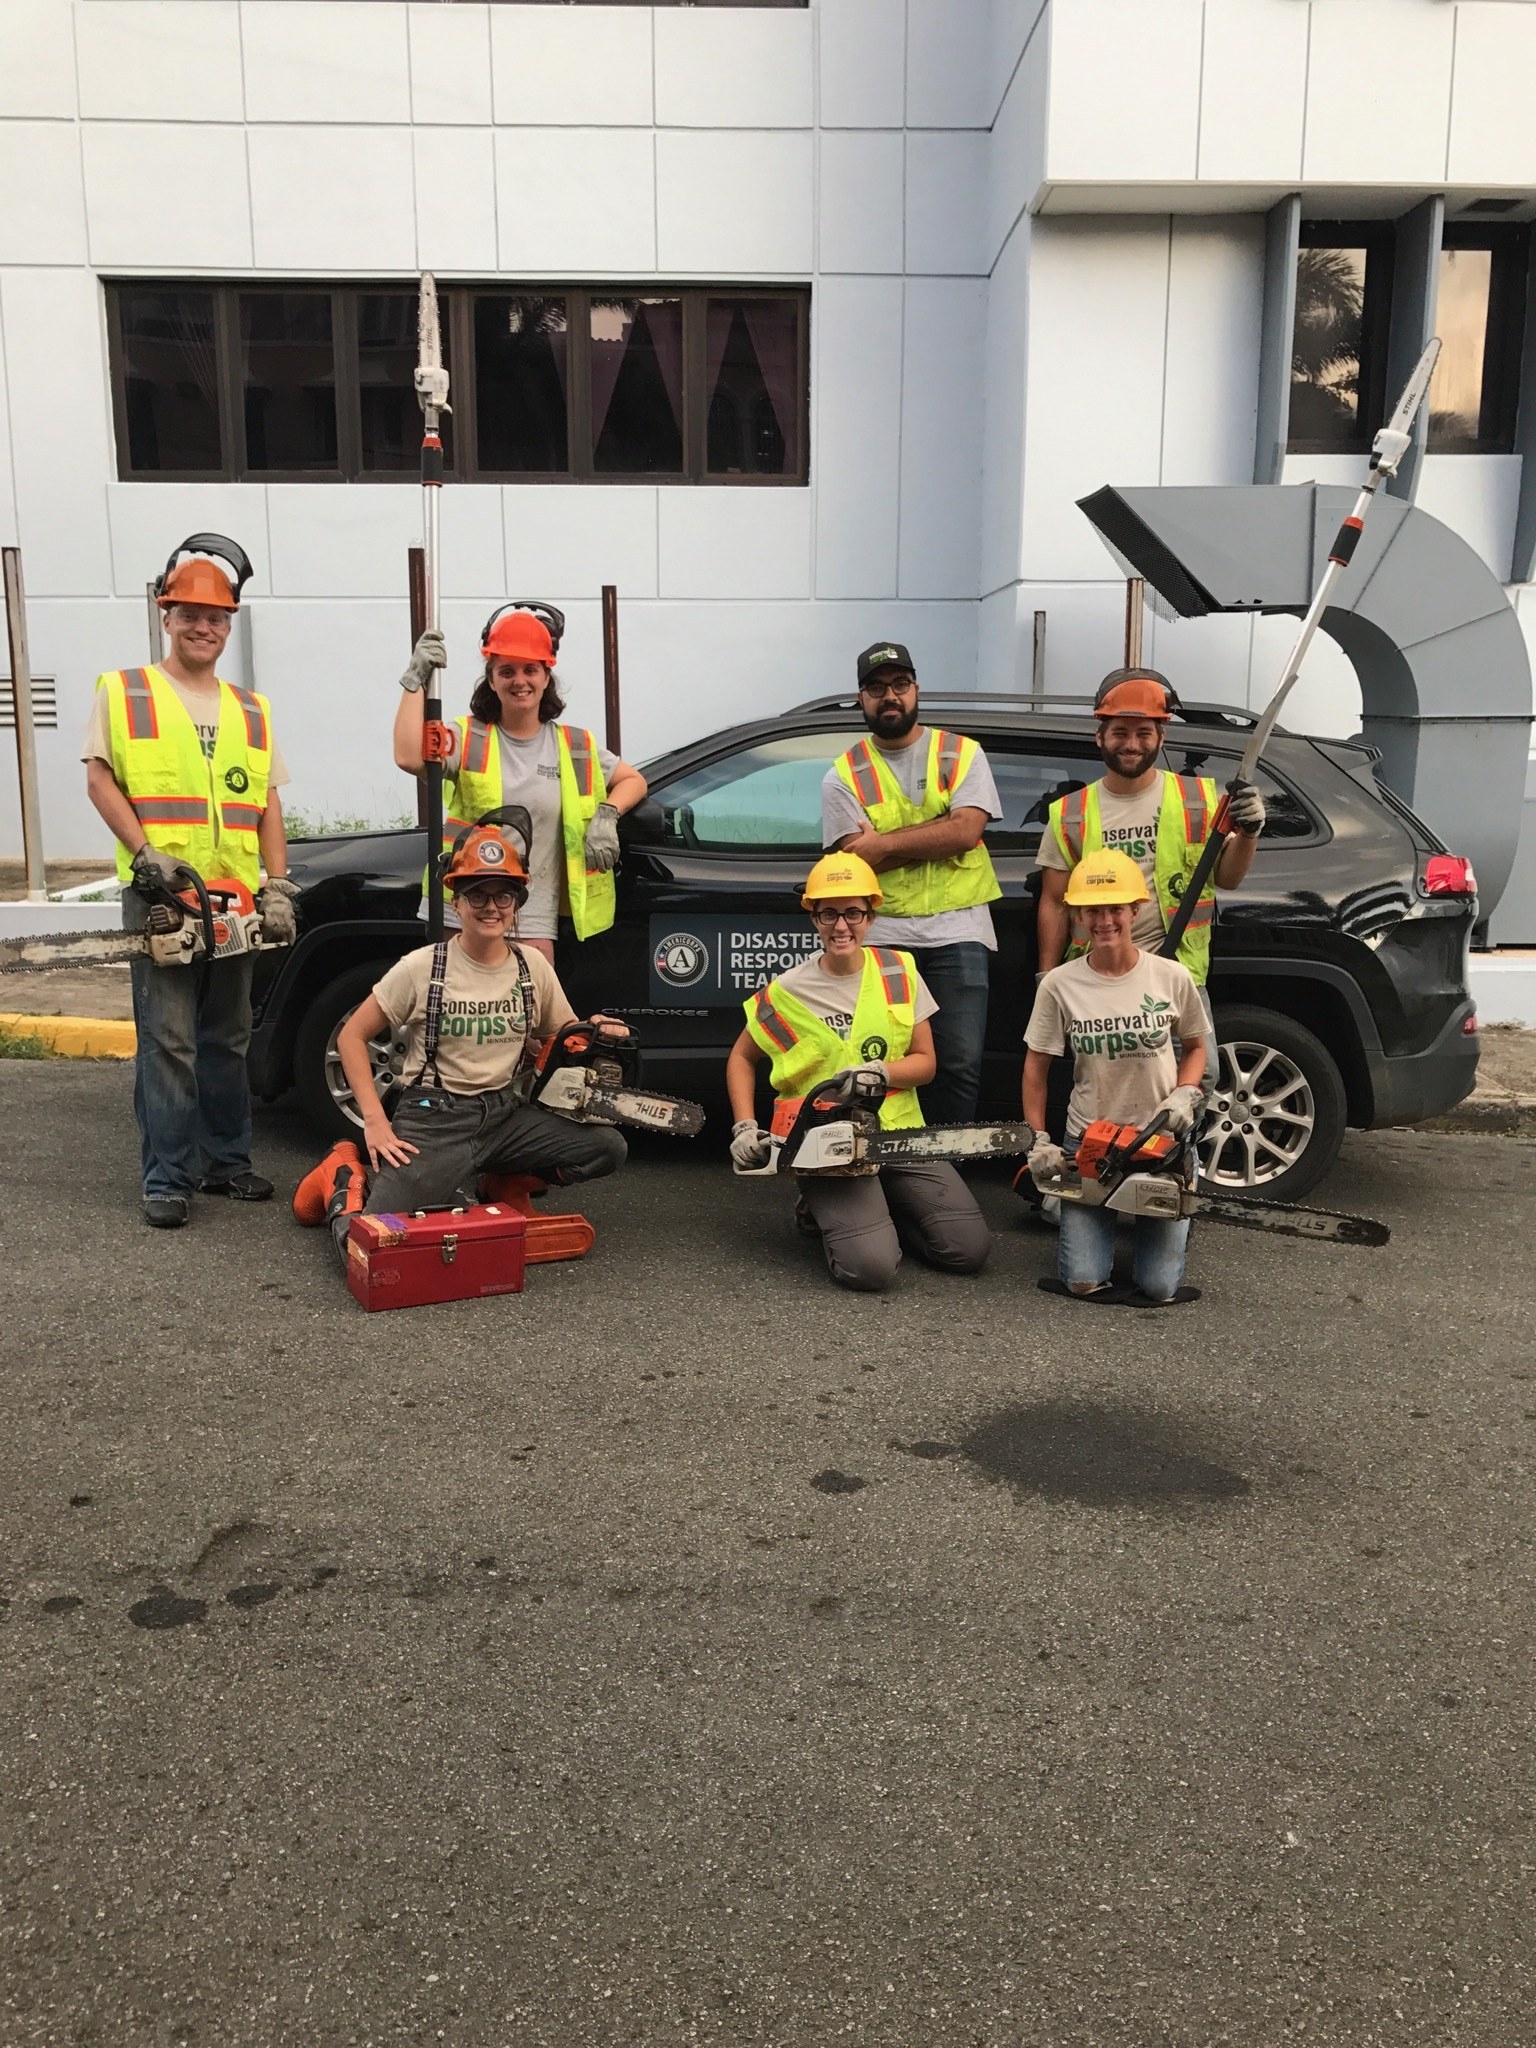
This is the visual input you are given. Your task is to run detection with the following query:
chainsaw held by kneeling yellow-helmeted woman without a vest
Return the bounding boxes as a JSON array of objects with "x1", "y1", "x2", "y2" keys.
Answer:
[{"x1": 1036, "y1": 1110, "x2": 1391, "y2": 1247}]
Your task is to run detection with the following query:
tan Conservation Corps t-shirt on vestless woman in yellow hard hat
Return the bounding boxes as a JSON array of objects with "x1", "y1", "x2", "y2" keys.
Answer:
[{"x1": 1024, "y1": 952, "x2": 1210, "y2": 1139}]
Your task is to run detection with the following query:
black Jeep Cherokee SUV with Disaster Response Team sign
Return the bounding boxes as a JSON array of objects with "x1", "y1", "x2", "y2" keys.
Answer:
[{"x1": 250, "y1": 692, "x2": 1479, "y2": 1200}]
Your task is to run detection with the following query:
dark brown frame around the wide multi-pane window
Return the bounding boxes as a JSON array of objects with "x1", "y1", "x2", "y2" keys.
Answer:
[{"x1": 102, "y1": 274, "x2": 811, "y2": 489}]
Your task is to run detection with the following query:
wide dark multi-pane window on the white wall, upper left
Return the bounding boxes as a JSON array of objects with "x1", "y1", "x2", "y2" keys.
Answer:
[{"x1": 106, "y1": 283, "x2": 811, "y2": 485}]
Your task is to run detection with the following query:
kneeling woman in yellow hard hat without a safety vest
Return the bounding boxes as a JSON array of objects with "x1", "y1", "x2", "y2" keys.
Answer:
[{"x1": 1024, "y1": 852, "x2": 1208, "y2": 1307}]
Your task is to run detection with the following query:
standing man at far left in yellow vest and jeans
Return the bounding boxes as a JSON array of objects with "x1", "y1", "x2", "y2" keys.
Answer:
[{"x1": 82, "y1": 532, "x2": 299, "y2": 1231}]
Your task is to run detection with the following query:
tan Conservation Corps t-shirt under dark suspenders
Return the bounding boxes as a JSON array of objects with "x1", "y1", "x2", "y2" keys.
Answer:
[{"x1": 373, "y1": 940, "x2": 575, "y2": 1096}]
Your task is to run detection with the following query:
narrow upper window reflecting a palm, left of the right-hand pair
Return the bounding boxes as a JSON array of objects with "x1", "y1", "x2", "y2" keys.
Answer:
[{"x1": 1290, "y1": 221, "x2": 1393, "y2": 455}]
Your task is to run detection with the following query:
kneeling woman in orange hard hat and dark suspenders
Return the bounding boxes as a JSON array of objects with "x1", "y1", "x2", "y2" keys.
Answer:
[{"x1": 293, "y1": 825, "x2": 627, "y2": 1266}]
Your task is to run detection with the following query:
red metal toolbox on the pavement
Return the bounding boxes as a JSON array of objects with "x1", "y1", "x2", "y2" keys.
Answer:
[{"x1": 346, "y1": 1202, "x2": 528, "y2": 1309}]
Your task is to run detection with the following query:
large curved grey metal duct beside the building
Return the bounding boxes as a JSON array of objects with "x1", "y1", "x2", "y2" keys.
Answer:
[{"x1": 1079, "y1": 483, "x2": 1532, "y2": 918}]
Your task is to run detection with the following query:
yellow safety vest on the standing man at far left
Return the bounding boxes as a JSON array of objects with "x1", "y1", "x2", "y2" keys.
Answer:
[{"x1": 96, "y1": 668, "x2": 272, "y2": 895}]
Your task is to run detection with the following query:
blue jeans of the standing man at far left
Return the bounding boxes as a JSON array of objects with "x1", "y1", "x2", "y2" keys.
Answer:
[{"x1": 129, "y1": 958, "x2": 254, "y2": 1194}]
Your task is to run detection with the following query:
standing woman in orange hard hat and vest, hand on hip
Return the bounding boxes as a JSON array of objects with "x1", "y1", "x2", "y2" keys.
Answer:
[{"x1": 395, "y1": 598, "x2": 645, "y2": 961}]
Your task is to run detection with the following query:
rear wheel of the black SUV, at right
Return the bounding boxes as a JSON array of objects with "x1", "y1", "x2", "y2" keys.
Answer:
[{"x1": 1200, "y1": 1008, "x2": 1346, "y2": 1202}]
